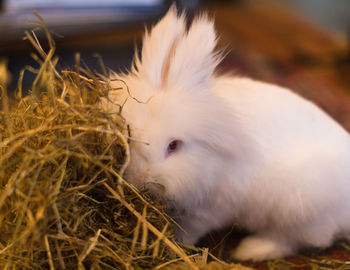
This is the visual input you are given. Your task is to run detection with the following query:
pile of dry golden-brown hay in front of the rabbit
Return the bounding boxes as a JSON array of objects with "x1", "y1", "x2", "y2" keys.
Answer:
[{"x1": 0, "y1": 17, "x2": 249, "y2": 269}]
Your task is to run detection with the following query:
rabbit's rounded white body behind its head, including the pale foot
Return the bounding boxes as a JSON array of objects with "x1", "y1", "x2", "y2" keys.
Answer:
[{"x1": 180, "y1": 78, "x2": 350, "y2": 260}]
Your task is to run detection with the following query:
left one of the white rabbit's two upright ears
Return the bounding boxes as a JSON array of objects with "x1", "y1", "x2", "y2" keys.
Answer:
[{"x1": 135, "y1": 5, "x2": 186, "y2": 87}]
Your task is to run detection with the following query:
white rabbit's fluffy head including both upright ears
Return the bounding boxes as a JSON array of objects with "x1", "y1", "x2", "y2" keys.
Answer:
[{"x1": 110, "y1": 7, "x2": 238, "y2": 200}]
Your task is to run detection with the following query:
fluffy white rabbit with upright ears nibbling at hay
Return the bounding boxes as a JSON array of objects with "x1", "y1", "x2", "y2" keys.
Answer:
[{"x1": 105, "y1": 7, "x2": 350, "y2": 260}]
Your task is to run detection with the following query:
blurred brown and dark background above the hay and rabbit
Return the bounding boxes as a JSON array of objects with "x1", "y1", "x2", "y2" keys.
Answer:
[{"x1": 0, "y1": 0, "x2": 350, "y2": 130}]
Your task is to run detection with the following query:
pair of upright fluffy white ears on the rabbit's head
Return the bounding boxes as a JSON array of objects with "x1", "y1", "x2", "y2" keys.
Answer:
[{"x1": 136, "y1": 6, "x2": 221, "y2": 90}]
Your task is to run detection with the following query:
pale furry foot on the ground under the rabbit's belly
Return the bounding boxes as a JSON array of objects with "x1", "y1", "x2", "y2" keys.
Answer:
[{"x1": 232, "y1": 235, "x2": 293, "y2": 261}]
